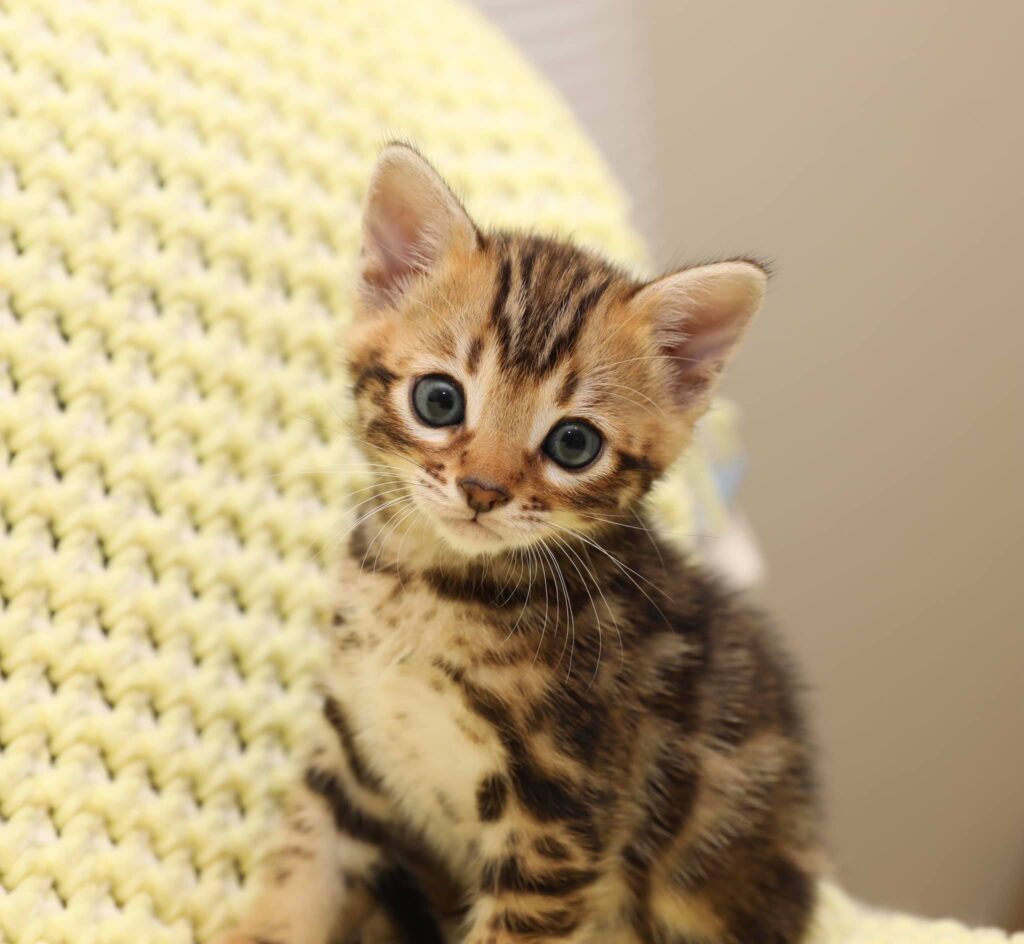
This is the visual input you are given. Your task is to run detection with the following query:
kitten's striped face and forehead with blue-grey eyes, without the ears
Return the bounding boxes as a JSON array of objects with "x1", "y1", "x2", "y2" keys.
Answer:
[{"x1": 353, "y1": 238, "x2": 686, "y2": 551}]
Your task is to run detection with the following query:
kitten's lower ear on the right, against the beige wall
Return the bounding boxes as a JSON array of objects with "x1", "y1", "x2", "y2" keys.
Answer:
[{"x1": 636, "y1": 260, "x2": 768, "y2": 405}]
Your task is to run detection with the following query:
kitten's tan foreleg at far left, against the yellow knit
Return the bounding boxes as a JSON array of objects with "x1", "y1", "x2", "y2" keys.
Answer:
[{"x1": 215, "y1": 766, "x2": 383, "y2": 944}]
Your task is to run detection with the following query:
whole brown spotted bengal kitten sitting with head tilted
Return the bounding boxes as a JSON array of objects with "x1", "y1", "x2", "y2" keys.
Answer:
[{"x1": 214, "y1": 144, "x2": 818, "y2": 944}]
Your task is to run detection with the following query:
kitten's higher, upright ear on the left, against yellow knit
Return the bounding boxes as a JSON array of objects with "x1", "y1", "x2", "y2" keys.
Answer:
[{"x1": 358, "y1": 144, "x2": 479, "y2": 312}]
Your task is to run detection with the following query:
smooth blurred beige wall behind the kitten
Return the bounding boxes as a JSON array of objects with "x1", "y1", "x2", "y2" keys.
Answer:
[{"x1": 475, "y1": 0, "x2": 1024, "y2": 928}]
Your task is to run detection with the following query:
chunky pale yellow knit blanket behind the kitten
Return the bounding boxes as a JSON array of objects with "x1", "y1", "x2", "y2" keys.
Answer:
[{"x1": 0, "y1": 0, "x2": 1015, "y2": 944}]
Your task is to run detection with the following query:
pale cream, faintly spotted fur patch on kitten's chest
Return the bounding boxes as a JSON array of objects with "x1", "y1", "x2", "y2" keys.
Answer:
[{"x1": 331, "y1": 581, "x2": 502, "y2": 857}]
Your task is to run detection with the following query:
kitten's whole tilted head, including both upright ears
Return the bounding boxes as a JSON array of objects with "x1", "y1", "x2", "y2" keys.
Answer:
[{"x1": 350, "y1": 144, "x2": 766, "y2": 555}]
